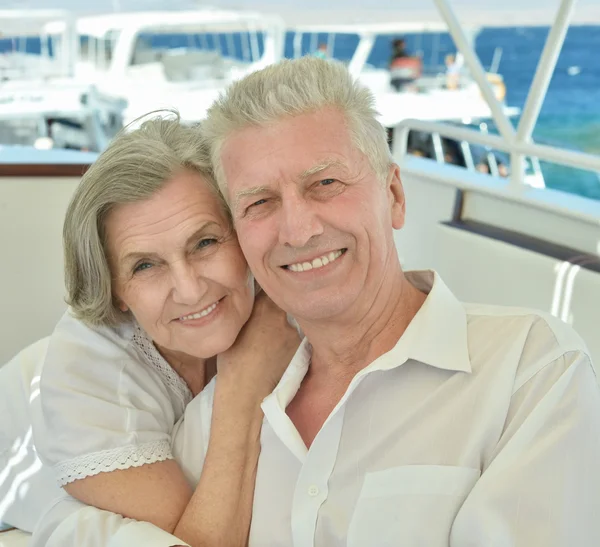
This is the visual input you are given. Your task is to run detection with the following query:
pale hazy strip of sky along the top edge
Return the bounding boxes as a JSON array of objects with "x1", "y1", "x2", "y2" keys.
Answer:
[{"x1": 0, "y1": 0, "x2": 600, "y2": 26}]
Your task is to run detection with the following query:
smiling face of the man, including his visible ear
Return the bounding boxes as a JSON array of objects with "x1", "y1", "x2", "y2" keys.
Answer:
[{"x1": 221, "y1": 108, "x2": 404, "y2": 321}]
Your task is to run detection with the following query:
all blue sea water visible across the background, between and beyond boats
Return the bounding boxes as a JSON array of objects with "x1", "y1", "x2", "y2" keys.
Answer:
[{"x1": 0, "y1": 26, "x2": 600, "y2": 199}]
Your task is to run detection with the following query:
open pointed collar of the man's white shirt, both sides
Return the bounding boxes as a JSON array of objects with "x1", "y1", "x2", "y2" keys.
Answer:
[{"x1": 273, "y1": 270, "x2": 471, "y2": 408}]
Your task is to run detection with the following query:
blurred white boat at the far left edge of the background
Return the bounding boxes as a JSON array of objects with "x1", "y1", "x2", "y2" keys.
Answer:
[{"x1": 0, "y1": 10, "x2": 126, "y2": 151}]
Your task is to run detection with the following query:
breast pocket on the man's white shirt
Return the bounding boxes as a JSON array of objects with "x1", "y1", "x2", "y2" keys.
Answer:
[{"x1": 347, "y1": 465, "x2": 480, "y2": 547}]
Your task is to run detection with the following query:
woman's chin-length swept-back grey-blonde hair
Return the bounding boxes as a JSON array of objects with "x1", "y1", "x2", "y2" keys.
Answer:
[{"x1": 63, "y1": 112, "x2": 225, "y2": 326}]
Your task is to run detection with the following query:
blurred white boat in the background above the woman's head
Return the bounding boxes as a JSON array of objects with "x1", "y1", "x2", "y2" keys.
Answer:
[{"x1": 46, "y1": 9, "x2": 284, "y2": 123}]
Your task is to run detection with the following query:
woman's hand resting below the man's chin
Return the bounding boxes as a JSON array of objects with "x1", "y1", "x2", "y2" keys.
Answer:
[{"x1": 217, "y1": 291, "x2": 300, "y2": 399}]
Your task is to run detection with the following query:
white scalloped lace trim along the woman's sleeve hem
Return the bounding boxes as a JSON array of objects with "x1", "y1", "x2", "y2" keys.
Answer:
[{"x1": 54, "y1": 439, "x2": 173, "y2": 486}]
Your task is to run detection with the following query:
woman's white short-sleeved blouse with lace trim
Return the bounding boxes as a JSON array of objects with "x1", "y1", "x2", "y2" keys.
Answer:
[{"x1": 31, "y1": 311, "x2": 192, "y2": 485}]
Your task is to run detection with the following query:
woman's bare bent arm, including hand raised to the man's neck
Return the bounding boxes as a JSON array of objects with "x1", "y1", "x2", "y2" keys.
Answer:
[{"x1": 65, "y1": 295, "x2": 299, "y2": 547}]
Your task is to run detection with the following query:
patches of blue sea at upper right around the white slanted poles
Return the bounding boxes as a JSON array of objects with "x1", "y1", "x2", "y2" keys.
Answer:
[{"x1": 477, "y1": 26, "x2": 600, "y2": 199}]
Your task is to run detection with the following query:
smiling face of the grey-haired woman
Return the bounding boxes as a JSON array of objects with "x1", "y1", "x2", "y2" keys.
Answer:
[{"x1": 105, "y1": 171, "x2": 254, "y2": 359}]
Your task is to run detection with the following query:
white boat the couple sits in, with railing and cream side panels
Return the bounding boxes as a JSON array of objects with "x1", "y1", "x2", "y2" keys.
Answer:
[{"x1": 0, "y1": 0, "x2": 600, "y2": 547}]
